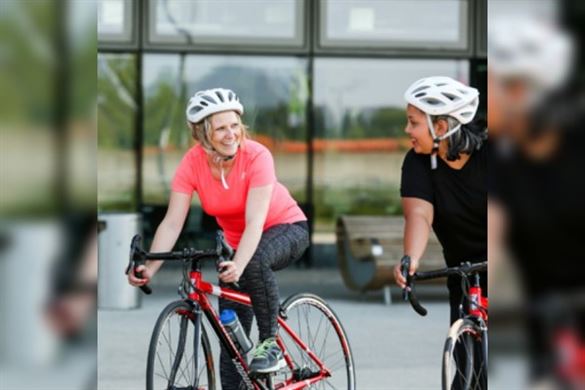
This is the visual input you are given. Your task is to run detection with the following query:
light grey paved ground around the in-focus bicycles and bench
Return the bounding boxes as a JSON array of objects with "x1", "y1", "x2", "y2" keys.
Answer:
[{"x1": 98, "y1": 269, "x2": 515, "y2": 390}]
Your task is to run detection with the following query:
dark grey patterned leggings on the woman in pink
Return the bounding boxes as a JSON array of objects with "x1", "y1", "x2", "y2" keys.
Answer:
[{"x1": 219, "y1": 222, "x2": 309, "y2": 390}]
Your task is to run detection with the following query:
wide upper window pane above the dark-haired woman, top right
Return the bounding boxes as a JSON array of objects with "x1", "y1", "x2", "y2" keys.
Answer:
[{"x1": 321, "y1": 0, "x2": 467, "y2": 49}]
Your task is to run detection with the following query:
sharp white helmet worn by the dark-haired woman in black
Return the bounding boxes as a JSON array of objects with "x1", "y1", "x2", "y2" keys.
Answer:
[{"x1": 404, "y1": 76, "x2": 479, "y2": 124}]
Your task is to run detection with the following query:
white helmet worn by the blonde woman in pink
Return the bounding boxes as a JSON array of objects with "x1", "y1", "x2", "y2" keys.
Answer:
[{"x1": 186, "y1": 88, "x2": 244, "y2": 123}]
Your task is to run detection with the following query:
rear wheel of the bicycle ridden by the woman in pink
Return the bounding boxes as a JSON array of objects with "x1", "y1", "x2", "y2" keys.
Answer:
[{"x1": 274, "y1": 294, "x2": 355, "y2": 390}]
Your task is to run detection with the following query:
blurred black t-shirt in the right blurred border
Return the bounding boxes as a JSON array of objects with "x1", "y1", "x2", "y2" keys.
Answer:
[{"x1": 490, "y1": 133, "x2": 585, "y2": 294}]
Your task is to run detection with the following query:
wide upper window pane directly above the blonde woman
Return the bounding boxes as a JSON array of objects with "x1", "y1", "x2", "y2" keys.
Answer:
[{"x1": 150, "y1": 0, "x2": 303, "y2": 45}]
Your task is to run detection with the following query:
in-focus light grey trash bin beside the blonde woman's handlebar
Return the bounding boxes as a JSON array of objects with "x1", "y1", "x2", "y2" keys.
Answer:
[{"x1": 98, "y1": 213, "x2": 141, "y2": 309}]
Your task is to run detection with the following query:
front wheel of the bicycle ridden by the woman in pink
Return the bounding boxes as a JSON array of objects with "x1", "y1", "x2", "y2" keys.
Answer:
[{"x1": 146, "y1": 301, "x2": 215, "y2": 390}]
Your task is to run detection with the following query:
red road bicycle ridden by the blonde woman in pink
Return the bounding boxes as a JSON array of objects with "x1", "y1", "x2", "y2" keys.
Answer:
[{"x1": 126, "y1": 232, "x2": 355, "y2": 390}]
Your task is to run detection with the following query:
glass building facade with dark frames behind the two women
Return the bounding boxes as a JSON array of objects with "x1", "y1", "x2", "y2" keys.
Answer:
[{"x1": 98, "y1": 0, "x2": 487, "y2": 262}]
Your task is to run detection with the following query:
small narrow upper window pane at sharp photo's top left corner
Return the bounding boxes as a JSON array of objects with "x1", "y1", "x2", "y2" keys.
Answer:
[{"x1": 97, "y1": 0, "x2": 132, "y2": 42}]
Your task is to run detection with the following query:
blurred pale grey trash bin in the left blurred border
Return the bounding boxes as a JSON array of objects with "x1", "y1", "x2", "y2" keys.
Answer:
[{"x1": 0, "y1": 220, "x2": 64, "y2": 366}]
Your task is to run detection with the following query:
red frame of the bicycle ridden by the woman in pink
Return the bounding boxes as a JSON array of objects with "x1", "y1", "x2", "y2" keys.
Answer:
[{"x1": 187, "y1": 263, "x2": 330, "y2": 390}]
